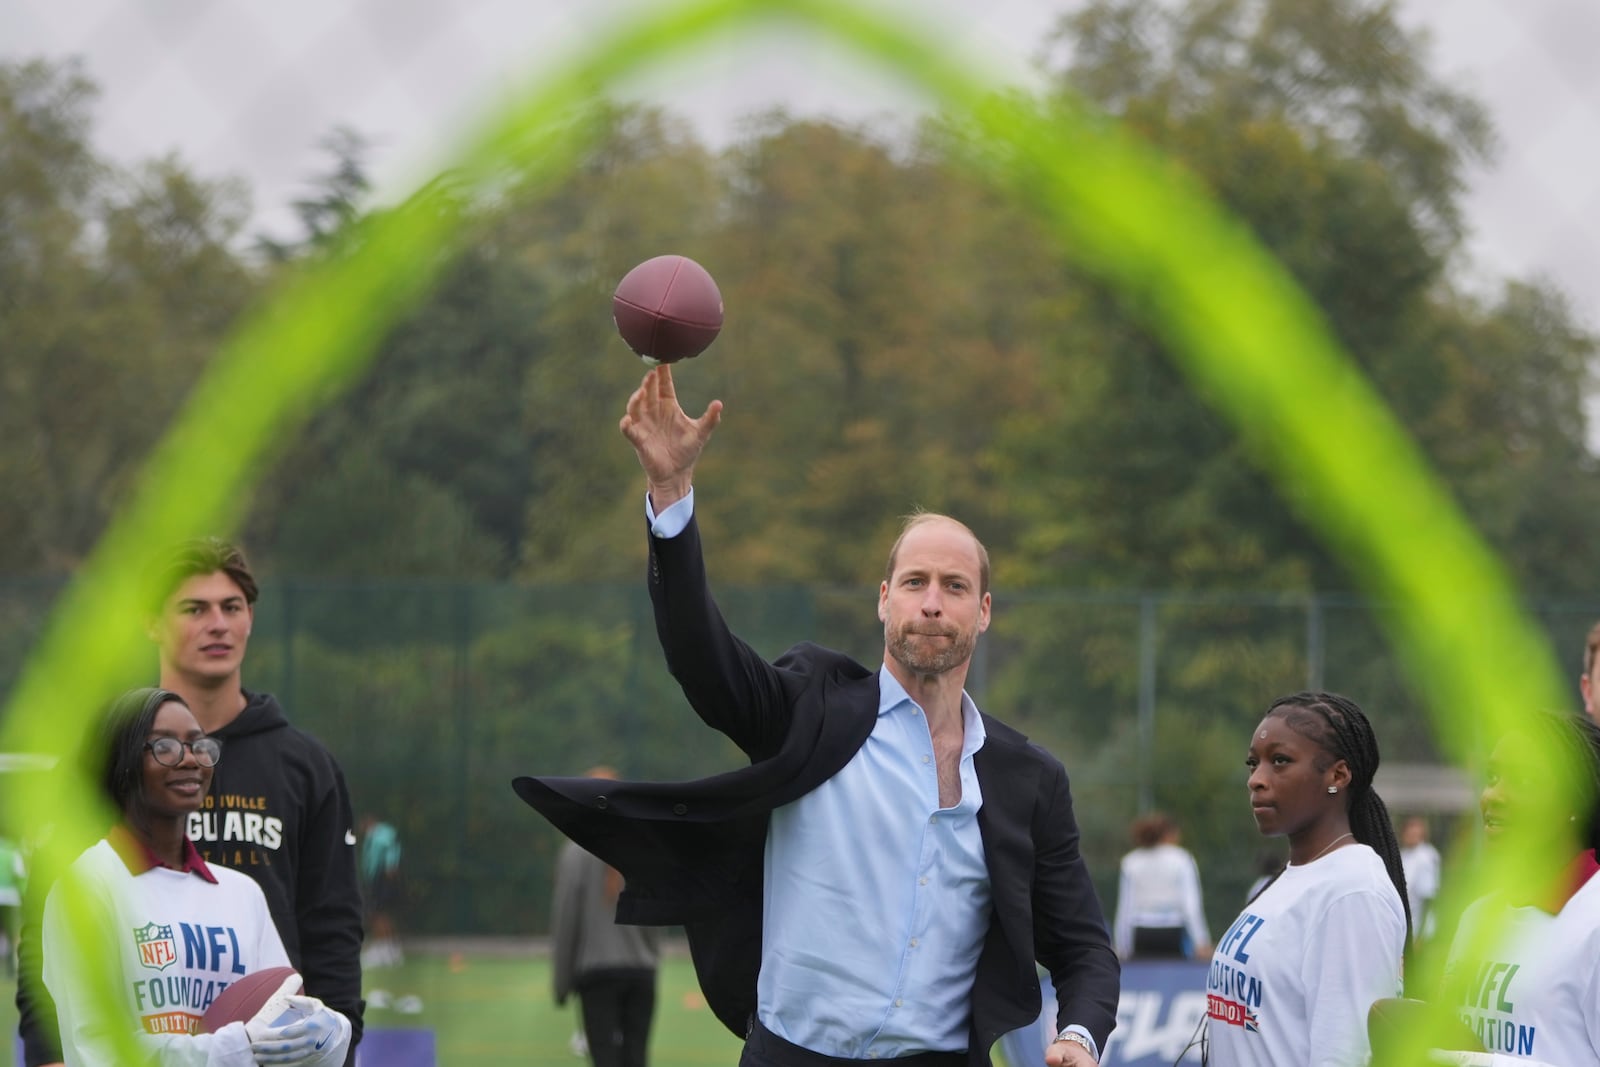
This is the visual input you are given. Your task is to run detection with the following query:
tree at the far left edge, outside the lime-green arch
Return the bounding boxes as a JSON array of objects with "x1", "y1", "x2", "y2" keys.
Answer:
[{"x1": 0, "y1": 61, "x2": 256, "y2": 573}]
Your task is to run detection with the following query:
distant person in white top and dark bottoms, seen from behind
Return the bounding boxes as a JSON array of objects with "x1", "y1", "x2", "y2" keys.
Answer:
[{"x1": 1112, "y1": 811, "x2": 1211, "y2": 960}]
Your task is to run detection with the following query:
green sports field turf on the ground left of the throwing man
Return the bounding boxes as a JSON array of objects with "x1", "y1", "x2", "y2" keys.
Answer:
[{"x1": 0, "y1": 952, "x2": 739, "y2": 1067}]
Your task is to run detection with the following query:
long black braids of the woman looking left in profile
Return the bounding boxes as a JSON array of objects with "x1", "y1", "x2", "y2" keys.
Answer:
[{"x1": 1267, "y1": 693, "x2": 1411, "y2": 950}]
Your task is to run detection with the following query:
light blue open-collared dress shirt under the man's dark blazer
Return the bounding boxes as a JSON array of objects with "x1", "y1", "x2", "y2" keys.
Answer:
[{"x1": 757, "y1": 667, "x2": 990, "y2": 1059}]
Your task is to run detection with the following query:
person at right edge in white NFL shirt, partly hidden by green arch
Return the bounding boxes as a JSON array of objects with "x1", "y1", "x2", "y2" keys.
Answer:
[{"x1": 1445, "y1": 703, "x2": 1600, "y2": 1067}]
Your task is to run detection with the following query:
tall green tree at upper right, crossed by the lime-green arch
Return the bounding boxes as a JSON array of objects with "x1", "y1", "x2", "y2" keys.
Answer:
[{"x1": 1032, "y1": 0, "x2": 1486, "y2": 589}]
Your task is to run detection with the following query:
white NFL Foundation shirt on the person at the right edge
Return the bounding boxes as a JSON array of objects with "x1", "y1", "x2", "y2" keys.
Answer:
[{"x1": 1445, "y1": 877, "x2": 1600, "y2": 1067}]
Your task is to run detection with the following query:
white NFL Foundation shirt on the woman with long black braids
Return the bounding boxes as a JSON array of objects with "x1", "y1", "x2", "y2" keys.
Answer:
[{"x1": 1206, "y1": 845, "x2": 1405, "y2": 1067}]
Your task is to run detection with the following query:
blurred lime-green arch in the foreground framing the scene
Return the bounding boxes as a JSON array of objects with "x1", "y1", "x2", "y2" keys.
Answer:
[{"x1": 0, "y1": 0, "x2": 1570, "y2": 1059}]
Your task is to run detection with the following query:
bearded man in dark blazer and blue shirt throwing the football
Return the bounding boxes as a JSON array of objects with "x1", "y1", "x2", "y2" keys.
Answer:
[{"x1": 514, "y1": 366, "x2": 1120, "y2": 1067}]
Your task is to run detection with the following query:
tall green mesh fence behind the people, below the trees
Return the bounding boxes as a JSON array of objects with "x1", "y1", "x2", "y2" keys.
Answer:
[{"x1": 0, "y1": 581, "x2": 1600, "y2": 936}]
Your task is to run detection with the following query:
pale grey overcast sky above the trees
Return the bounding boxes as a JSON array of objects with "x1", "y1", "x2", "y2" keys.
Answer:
[{"x1": 0, "y1": 0, "x2": 1600, "y2": 406}]
